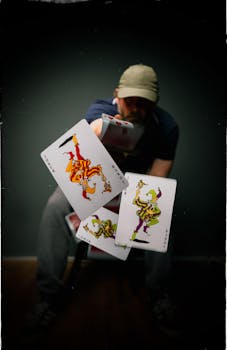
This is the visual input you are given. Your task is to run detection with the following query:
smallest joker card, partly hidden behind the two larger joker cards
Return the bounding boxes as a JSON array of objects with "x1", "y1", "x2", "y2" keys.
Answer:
[{"x1": 76, "y1": 208, "x2": 130, "y2": 260}]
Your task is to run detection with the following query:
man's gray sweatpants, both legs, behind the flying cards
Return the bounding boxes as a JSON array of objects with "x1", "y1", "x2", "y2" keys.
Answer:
[{"x1": 37, "y1": 187, "x2": 172, "y2": 299}]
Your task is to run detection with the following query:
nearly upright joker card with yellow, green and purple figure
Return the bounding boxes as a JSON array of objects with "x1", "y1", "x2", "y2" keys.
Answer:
[{"x1": 116, "y1": 172, "x2": 177, "y2": 253}]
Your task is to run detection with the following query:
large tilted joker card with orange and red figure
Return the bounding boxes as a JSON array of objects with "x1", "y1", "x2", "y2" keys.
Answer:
[{"x1": 41, "y1": 119, "x2": 128, "y2": 220}]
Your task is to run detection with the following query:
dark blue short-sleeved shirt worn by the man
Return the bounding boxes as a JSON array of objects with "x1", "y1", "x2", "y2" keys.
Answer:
[{"x1": 85, "y1": 98, "x2": 179, "y2": 174}]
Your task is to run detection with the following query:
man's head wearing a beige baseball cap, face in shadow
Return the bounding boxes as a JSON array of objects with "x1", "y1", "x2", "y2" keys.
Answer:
[{"x1": 116, "y1": 64, "x2": 158, "y2": 122}]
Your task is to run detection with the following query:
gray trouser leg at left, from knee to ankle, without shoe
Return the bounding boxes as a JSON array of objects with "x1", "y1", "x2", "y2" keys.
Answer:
[{"x1": 37, "y1": 187, "x2": 73, "y2": 302}]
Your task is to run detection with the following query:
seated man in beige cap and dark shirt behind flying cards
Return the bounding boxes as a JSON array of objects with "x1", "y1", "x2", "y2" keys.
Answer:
[{"x1": 23, "y1": 64, "x2": 179, "y2": 336}]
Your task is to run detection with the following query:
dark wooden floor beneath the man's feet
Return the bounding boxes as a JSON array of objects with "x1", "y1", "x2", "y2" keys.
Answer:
[{"x1": 2, "y1": 259, "x2": 225, "y2": 350}]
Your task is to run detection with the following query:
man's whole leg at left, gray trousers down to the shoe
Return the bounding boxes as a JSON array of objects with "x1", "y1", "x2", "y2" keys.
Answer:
[{"x1": 21, "y1": 187, "x2": 75, "y2": 346}]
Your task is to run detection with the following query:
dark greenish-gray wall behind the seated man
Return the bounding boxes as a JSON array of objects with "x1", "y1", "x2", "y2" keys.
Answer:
[{"x1": 1, "y1": 1, "x2": 225, "y2": 259}]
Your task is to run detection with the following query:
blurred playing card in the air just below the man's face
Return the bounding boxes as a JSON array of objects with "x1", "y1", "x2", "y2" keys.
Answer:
[{"x1": 100, "y1": 113, "x2": 144, "y2": 151}]
